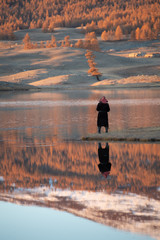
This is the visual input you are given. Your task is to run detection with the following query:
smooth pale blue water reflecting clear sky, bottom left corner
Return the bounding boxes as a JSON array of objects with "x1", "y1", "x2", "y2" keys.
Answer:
[{"x1": 0, "y1": 202, "x2": 152, "y2": 240}]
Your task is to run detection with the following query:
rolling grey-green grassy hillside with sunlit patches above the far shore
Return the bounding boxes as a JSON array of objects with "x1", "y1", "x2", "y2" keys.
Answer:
[{"x1": 0, "y1": 28, "x2": 160, "y2": 90}]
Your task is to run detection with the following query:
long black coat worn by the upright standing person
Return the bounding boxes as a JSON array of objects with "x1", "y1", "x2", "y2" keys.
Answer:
[{"x1": 96, "y1": 102, "x2": 110, "y2": 127}]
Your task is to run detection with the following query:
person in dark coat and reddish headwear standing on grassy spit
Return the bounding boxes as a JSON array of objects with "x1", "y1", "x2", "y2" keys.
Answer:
[{"x1": 96, "y1": 96, "x2": 110, "y2": 133}]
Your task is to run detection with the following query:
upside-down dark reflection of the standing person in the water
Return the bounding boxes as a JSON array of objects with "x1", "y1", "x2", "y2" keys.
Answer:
[{"x1": 98, "y1": 143, "x2": 111, "y2": 178}]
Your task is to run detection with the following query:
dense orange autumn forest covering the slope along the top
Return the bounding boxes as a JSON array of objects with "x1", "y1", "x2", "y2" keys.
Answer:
[{"x1": 0, "y1": 0, "x2": 160, "y2": 40}]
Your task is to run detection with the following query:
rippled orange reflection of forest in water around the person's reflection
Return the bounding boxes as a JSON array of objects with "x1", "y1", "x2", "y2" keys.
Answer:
[{"x1": 0, "y1": 132, "x2": 160, "y2": 198}]
